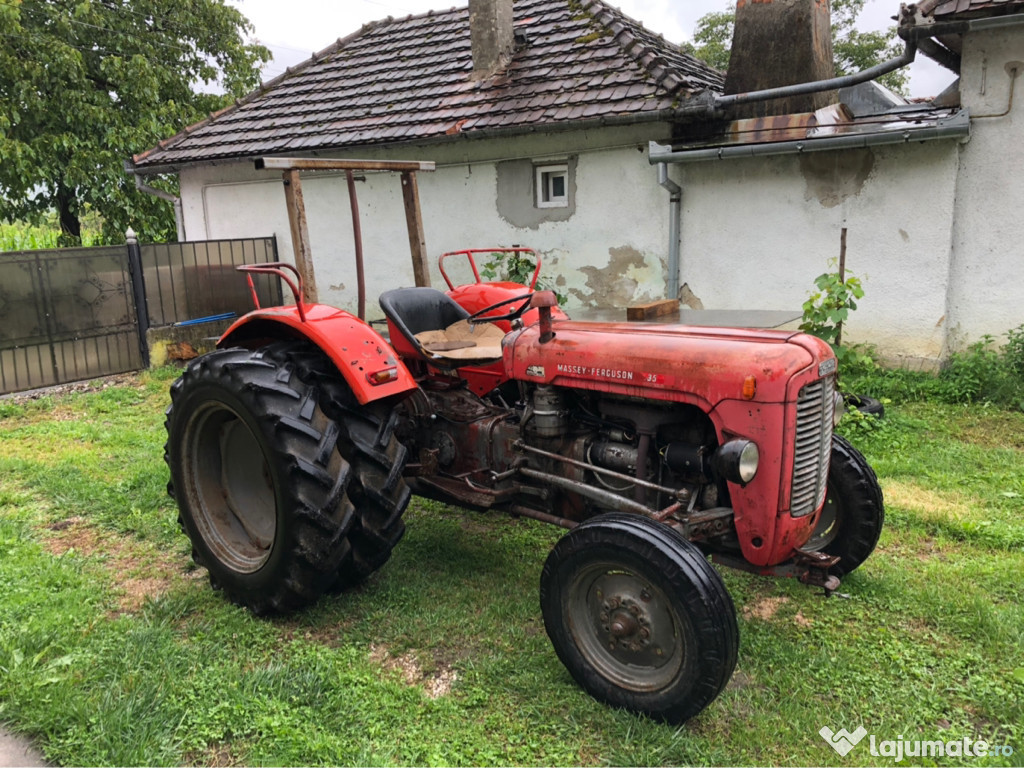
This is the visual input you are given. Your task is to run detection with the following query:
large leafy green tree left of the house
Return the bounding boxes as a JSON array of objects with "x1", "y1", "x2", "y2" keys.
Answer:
[{"x1": 0, "y1": 0, "x2": 269, "y2": 245}]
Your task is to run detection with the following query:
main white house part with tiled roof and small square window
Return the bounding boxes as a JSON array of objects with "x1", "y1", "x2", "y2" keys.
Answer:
[{"x1": 125, "y1": 0, "x2": 723, "y2": 319}]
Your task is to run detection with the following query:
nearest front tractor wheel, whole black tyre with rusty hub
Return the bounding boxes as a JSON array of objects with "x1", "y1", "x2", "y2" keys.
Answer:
[{"x1": 541, "y1": 513, "x2": 739, "y2": 723}]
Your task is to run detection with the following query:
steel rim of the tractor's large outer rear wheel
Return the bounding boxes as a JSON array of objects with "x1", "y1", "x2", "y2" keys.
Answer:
[{"x1": 185, "y1": 403, "x2": 278, "y2": 573}]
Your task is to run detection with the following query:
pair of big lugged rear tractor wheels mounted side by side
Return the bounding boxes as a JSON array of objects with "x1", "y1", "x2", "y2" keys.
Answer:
[{"x1": 165, "y1": 341, "x2": 411, "y2": 613}]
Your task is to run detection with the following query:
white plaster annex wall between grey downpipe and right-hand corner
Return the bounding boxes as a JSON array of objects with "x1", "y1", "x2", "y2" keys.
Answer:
[{"x1": 672, "y1": 140, "x2": 957, "y2": 362}]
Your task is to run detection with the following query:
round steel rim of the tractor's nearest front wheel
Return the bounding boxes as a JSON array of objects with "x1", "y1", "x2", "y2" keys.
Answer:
[{"x1": 566, "y1": 562, "x2": 687, "y2": 692}]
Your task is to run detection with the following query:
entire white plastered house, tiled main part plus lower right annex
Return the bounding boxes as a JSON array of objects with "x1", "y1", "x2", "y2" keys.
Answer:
[{"x1": 130, "y1": 0, "x2": 1024, "y2": 367}]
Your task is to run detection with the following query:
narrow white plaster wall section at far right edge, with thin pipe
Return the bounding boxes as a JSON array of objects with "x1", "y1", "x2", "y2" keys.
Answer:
[{"x1": 948, "y1": 27, "x2": 1024, "y2": 350}]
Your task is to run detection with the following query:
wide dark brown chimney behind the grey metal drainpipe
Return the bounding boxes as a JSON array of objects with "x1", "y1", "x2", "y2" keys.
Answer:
[{"x1": 725, "y1": 0, "x2": 837, "y2": 119}]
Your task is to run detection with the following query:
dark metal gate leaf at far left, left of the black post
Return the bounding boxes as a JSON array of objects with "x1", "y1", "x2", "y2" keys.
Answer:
[{"x1": 0, "y1": 246, "x2": 142, "y2": 393}]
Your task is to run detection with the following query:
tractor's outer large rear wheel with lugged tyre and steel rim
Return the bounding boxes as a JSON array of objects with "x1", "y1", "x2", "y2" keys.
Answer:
[{"x1": 165, "y1": 349, "x2": 355, "y2": 613}]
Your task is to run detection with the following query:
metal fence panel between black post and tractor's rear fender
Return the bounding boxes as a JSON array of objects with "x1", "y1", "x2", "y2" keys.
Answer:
[{"x1": 141, "y1": 238, "x2": 282, "y2": 326}]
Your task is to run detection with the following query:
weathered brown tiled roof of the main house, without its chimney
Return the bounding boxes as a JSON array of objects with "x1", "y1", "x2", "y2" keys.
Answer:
[{"x1": 134, "y1": 0, "x2": 724, "y2": 170}]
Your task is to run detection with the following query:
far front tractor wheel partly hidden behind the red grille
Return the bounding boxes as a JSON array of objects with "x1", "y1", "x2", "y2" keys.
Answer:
[{"x1": 802, "y1": 435, "x2": 885, "y2": 577}]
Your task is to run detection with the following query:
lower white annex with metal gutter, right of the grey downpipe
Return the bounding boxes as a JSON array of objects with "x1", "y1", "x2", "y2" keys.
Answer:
[{"x1": 650, "y1": 0, "x2": 1024, "y2": 368}]
